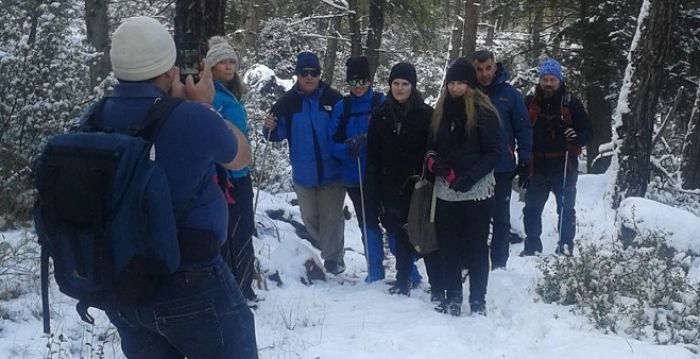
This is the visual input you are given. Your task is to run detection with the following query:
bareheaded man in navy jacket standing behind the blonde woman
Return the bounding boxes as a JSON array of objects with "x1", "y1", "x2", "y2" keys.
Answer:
[{"x1": 472, "y1": 50, "x2": 532, "y2": 269}]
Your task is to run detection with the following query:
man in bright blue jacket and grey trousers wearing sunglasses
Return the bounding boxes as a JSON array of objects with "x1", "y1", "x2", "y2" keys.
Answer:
[{"x1": 264, "y1": 52, "x2": 345, "y2": 274}]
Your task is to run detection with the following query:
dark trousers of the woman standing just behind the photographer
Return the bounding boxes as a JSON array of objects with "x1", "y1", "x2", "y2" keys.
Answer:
[{"x1": 221, "y1": 174, "x2": 255, "y2": 299}]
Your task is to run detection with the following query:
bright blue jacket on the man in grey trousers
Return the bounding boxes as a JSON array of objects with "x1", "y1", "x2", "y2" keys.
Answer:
[{"x1": 265, "y1": 82, "x2": 343, "y2": 187}]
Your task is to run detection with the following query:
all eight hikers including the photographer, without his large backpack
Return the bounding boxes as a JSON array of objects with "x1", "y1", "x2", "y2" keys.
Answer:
[{"x1": 35, "y1": 17, "x2": 590, "y2": 358}]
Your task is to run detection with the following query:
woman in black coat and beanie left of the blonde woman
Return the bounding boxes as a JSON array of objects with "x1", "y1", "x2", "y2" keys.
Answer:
[{"x1": 365, "y1": 63, "x2": 441, "y2": 295}]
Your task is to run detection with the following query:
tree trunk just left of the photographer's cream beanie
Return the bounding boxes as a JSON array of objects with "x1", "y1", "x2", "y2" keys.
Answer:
[{"x1": 85, "y1": 0, "x2": 111, "y2": 87}]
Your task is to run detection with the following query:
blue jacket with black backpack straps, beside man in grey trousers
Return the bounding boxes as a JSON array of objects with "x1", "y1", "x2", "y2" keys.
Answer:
[{"x1": 328, "y1": 87, "x2": 385, "y2": 186}]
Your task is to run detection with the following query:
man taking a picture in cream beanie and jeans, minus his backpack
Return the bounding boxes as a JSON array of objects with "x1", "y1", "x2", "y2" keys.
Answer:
[{"x1": 101, "y1": 16, "x2": 257, "y2": 359}]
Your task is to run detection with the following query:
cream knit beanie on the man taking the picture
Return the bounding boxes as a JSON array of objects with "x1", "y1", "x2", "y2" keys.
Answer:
[{"x1": 109, "y1": 16, "x2": 177, "y2": 81}]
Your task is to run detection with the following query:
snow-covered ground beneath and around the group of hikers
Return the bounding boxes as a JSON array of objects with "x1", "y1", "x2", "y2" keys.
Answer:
[{"x1": 0, "y1": 175, "x2": 700, "y2": 359}]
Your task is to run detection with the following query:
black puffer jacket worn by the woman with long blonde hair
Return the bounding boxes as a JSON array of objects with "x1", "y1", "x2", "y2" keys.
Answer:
[{"x1": 428, "y1": 97, "x2": 501, "y2": 190}]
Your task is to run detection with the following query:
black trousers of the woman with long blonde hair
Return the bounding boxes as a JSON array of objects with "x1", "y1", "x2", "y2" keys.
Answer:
[{"x1": 435, "y1": 198, "x2": 493, "y2": 303}]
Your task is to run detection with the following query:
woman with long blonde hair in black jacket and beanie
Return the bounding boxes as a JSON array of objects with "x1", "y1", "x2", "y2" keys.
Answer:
[{"x1": 426, "y1": 59, "x2": 500, "y2": 316}]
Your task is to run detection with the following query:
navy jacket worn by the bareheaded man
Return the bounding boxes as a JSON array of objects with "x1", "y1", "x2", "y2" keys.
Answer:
[{"x1": 482, "y1": 63, "x2": 532, "y2": 173}]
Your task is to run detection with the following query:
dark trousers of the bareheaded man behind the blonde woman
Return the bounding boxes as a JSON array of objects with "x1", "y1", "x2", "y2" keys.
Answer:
[{"x1": 491, "y1": 172, "x2": 513, "y2": 268}]
